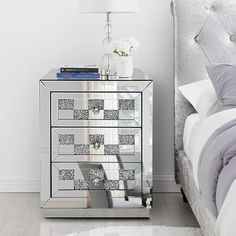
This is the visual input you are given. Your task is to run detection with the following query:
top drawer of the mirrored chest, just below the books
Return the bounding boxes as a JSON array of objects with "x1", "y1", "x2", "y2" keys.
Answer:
[{"x1": 51, "y1": 92, "x2": 141, "y2": 127}]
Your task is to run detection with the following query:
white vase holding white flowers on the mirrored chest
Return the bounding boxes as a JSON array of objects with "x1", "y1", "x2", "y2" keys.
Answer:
[{"x1": 115, "y1": 56, "x2": 134, "y2": 78}]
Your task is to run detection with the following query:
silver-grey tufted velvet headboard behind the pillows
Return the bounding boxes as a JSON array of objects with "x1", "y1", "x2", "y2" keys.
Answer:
[{"x1": 171, "y1": 0, "x2": 236, "y2": 182}]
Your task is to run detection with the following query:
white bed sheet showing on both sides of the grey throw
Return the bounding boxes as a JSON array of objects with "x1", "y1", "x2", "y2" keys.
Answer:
[{"x1": 184, "y1": 108, "x2": 236, "y2": 236}]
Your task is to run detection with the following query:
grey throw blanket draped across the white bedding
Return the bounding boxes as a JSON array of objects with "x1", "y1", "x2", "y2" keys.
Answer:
[{"x1": 198, "y1": 119, "x2": 236, "y2": 216}]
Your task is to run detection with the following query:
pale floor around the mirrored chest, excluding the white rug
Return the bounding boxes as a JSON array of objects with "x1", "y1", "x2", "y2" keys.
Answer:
[{"x1": 0, "y1": 193, "x2": 198, "y2": 236}]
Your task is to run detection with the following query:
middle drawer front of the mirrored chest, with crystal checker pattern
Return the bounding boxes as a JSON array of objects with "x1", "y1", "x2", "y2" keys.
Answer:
[{"x1": 52, "y1": 128, "x2": 141, "y2": 162}]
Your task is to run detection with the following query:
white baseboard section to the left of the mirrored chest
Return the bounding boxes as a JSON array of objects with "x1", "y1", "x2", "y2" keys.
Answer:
[{"x1": 0, "y1": 176, "x2": 40, "y2": 193}]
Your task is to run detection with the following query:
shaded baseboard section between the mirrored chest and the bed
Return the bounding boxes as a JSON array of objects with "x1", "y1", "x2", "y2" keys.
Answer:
[{"x1": 153, "y1": 175, "x2": 180, "y2": 193}]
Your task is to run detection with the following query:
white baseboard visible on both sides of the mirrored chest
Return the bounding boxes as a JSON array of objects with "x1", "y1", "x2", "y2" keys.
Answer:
[{"x1": 0, "y1": 175, "x2": 180, "y2": 193}]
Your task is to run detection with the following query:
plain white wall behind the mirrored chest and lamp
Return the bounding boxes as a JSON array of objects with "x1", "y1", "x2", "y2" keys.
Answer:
[{"x1": 0, "y1": 0, "x2": 177, "y2": 191}]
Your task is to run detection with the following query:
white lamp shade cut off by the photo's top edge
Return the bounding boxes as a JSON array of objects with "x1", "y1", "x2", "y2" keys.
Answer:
[{"x1": 78, "y1": 0, "x2": 139, "y2": 13}]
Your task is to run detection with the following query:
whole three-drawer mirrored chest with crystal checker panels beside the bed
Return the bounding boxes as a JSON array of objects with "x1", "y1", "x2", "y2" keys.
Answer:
[{"x1": 40, "y1": 70, "x2": 153, "y2": 218}]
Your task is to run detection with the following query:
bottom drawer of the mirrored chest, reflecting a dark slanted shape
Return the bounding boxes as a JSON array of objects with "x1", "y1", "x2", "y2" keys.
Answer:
[{"x1": 52, "y1": 163, "x2": 142, "y2": 208}]
